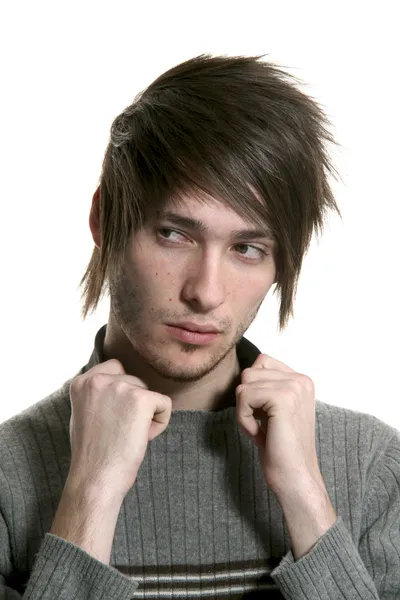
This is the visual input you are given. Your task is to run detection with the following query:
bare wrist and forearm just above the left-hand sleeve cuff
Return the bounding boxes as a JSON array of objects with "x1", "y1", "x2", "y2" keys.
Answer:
[{"x1": 49, "y1": 480, "x2": 123, "y2": 565}]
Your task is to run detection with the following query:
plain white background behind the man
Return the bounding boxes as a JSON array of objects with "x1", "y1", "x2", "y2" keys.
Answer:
[{"x1": 0, "y1": 0, "x2": 400, "y2": 428}]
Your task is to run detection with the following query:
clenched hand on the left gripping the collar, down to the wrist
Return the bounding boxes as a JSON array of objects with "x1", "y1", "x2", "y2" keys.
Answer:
[{"x1": 68, "y1": 359, "x2": 172, "y2": 503}]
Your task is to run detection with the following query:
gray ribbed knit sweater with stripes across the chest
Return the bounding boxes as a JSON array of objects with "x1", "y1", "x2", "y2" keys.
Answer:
[{"x1": 0, "y1": 325, "x2": 400, "y2": 600}]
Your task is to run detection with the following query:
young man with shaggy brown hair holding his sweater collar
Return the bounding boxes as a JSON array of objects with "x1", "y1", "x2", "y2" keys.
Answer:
[{"x1": 0, "y1": 55, "x2": 400, "y2": 600}]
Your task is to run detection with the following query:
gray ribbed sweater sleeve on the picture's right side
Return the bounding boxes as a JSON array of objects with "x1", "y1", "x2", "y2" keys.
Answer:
[{"x1": 271, "y1": 431, "x2": 400, "y2": 600}]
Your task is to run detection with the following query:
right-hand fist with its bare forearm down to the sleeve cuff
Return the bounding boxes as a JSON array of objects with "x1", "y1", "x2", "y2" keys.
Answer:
[{"x1": 236, "y1": 354, "x2": 337, "y2": 560}]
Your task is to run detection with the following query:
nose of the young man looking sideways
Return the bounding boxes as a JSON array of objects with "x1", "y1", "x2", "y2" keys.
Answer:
[{"x1": 182, "y1": 251, "x2": 226, "y2": 312}]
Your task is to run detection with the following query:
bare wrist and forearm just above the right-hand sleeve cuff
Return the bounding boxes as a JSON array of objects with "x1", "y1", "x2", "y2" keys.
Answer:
[{"x1": 278, "y1": 479, "x2": 337, "y2": 560}]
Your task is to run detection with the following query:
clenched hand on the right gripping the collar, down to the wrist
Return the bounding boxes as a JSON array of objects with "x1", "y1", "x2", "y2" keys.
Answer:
[{"x1": 236, "y1": 354, "x2": 321, "y2": 493}]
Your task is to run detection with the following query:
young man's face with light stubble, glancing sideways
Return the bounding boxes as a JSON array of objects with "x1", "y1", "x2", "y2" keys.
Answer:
[{"x1": 110, "y1": 198, "x2": 276, "y2": 382}]
